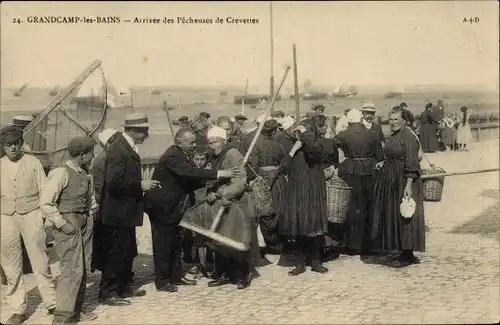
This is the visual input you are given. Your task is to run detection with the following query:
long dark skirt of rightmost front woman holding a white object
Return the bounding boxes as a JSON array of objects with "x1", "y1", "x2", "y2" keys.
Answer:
[{"x1": 371, "y1": 160, "x2": 425, "y2": 252}]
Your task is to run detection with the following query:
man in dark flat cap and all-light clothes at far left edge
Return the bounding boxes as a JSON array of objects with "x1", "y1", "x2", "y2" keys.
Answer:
[{"x1": 0, "y1": 125, "x2": 56, "y2": 324}]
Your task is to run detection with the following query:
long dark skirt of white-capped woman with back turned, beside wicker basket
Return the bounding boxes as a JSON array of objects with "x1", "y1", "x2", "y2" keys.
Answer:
[{"x1": 342, "y1": 174, "x2": 373, "y2": 250}]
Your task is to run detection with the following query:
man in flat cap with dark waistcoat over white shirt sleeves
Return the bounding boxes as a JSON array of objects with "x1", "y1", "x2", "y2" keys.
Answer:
[{"x1": 40, "y1": 136, "x2": 97, "y2": 324}]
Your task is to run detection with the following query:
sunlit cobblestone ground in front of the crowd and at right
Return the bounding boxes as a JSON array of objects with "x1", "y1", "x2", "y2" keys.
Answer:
[{"x1": 1, "y1": 141, "x2": 500, "y2": 324}]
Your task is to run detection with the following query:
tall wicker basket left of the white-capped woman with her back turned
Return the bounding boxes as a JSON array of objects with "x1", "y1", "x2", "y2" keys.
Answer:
[{"x1": 326, "y1": 176, "x2": 352, "y2": 223}]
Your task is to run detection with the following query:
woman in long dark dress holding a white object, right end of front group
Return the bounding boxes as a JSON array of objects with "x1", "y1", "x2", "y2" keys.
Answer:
[{"x1": 371, "y1": 109, "x2": 425, "y2": 267}]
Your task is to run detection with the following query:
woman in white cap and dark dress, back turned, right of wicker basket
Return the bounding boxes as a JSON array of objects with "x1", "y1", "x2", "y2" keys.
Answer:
[{"x1": 333, "y1": 109, "x2": 384, "y2": 255}]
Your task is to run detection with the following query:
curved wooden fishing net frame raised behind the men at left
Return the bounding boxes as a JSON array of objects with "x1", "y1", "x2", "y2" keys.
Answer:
[{"x1": 23, "y1": 60, "x2": 108, "y2": 163}]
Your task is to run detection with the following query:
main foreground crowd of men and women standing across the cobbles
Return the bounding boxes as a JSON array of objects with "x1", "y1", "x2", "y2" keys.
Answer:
[{"x1": 0, "y1": 98, "x2": 456, "y2": 324}]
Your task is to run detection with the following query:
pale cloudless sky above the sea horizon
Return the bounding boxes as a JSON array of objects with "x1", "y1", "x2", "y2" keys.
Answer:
[{"x1": 0, "y1": 1, "x2": 499, "y2": 89}]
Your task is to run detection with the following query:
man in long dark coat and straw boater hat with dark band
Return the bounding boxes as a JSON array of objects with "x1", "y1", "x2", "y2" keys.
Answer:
[{"x1": 99, "y1": 113, "x2": 158, "y2": 306}]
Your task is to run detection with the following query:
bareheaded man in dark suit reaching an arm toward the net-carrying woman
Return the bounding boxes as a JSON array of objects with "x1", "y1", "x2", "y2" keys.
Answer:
[{"x1": 145, "y1": 128, "x2": 241, "y2": 292}]
